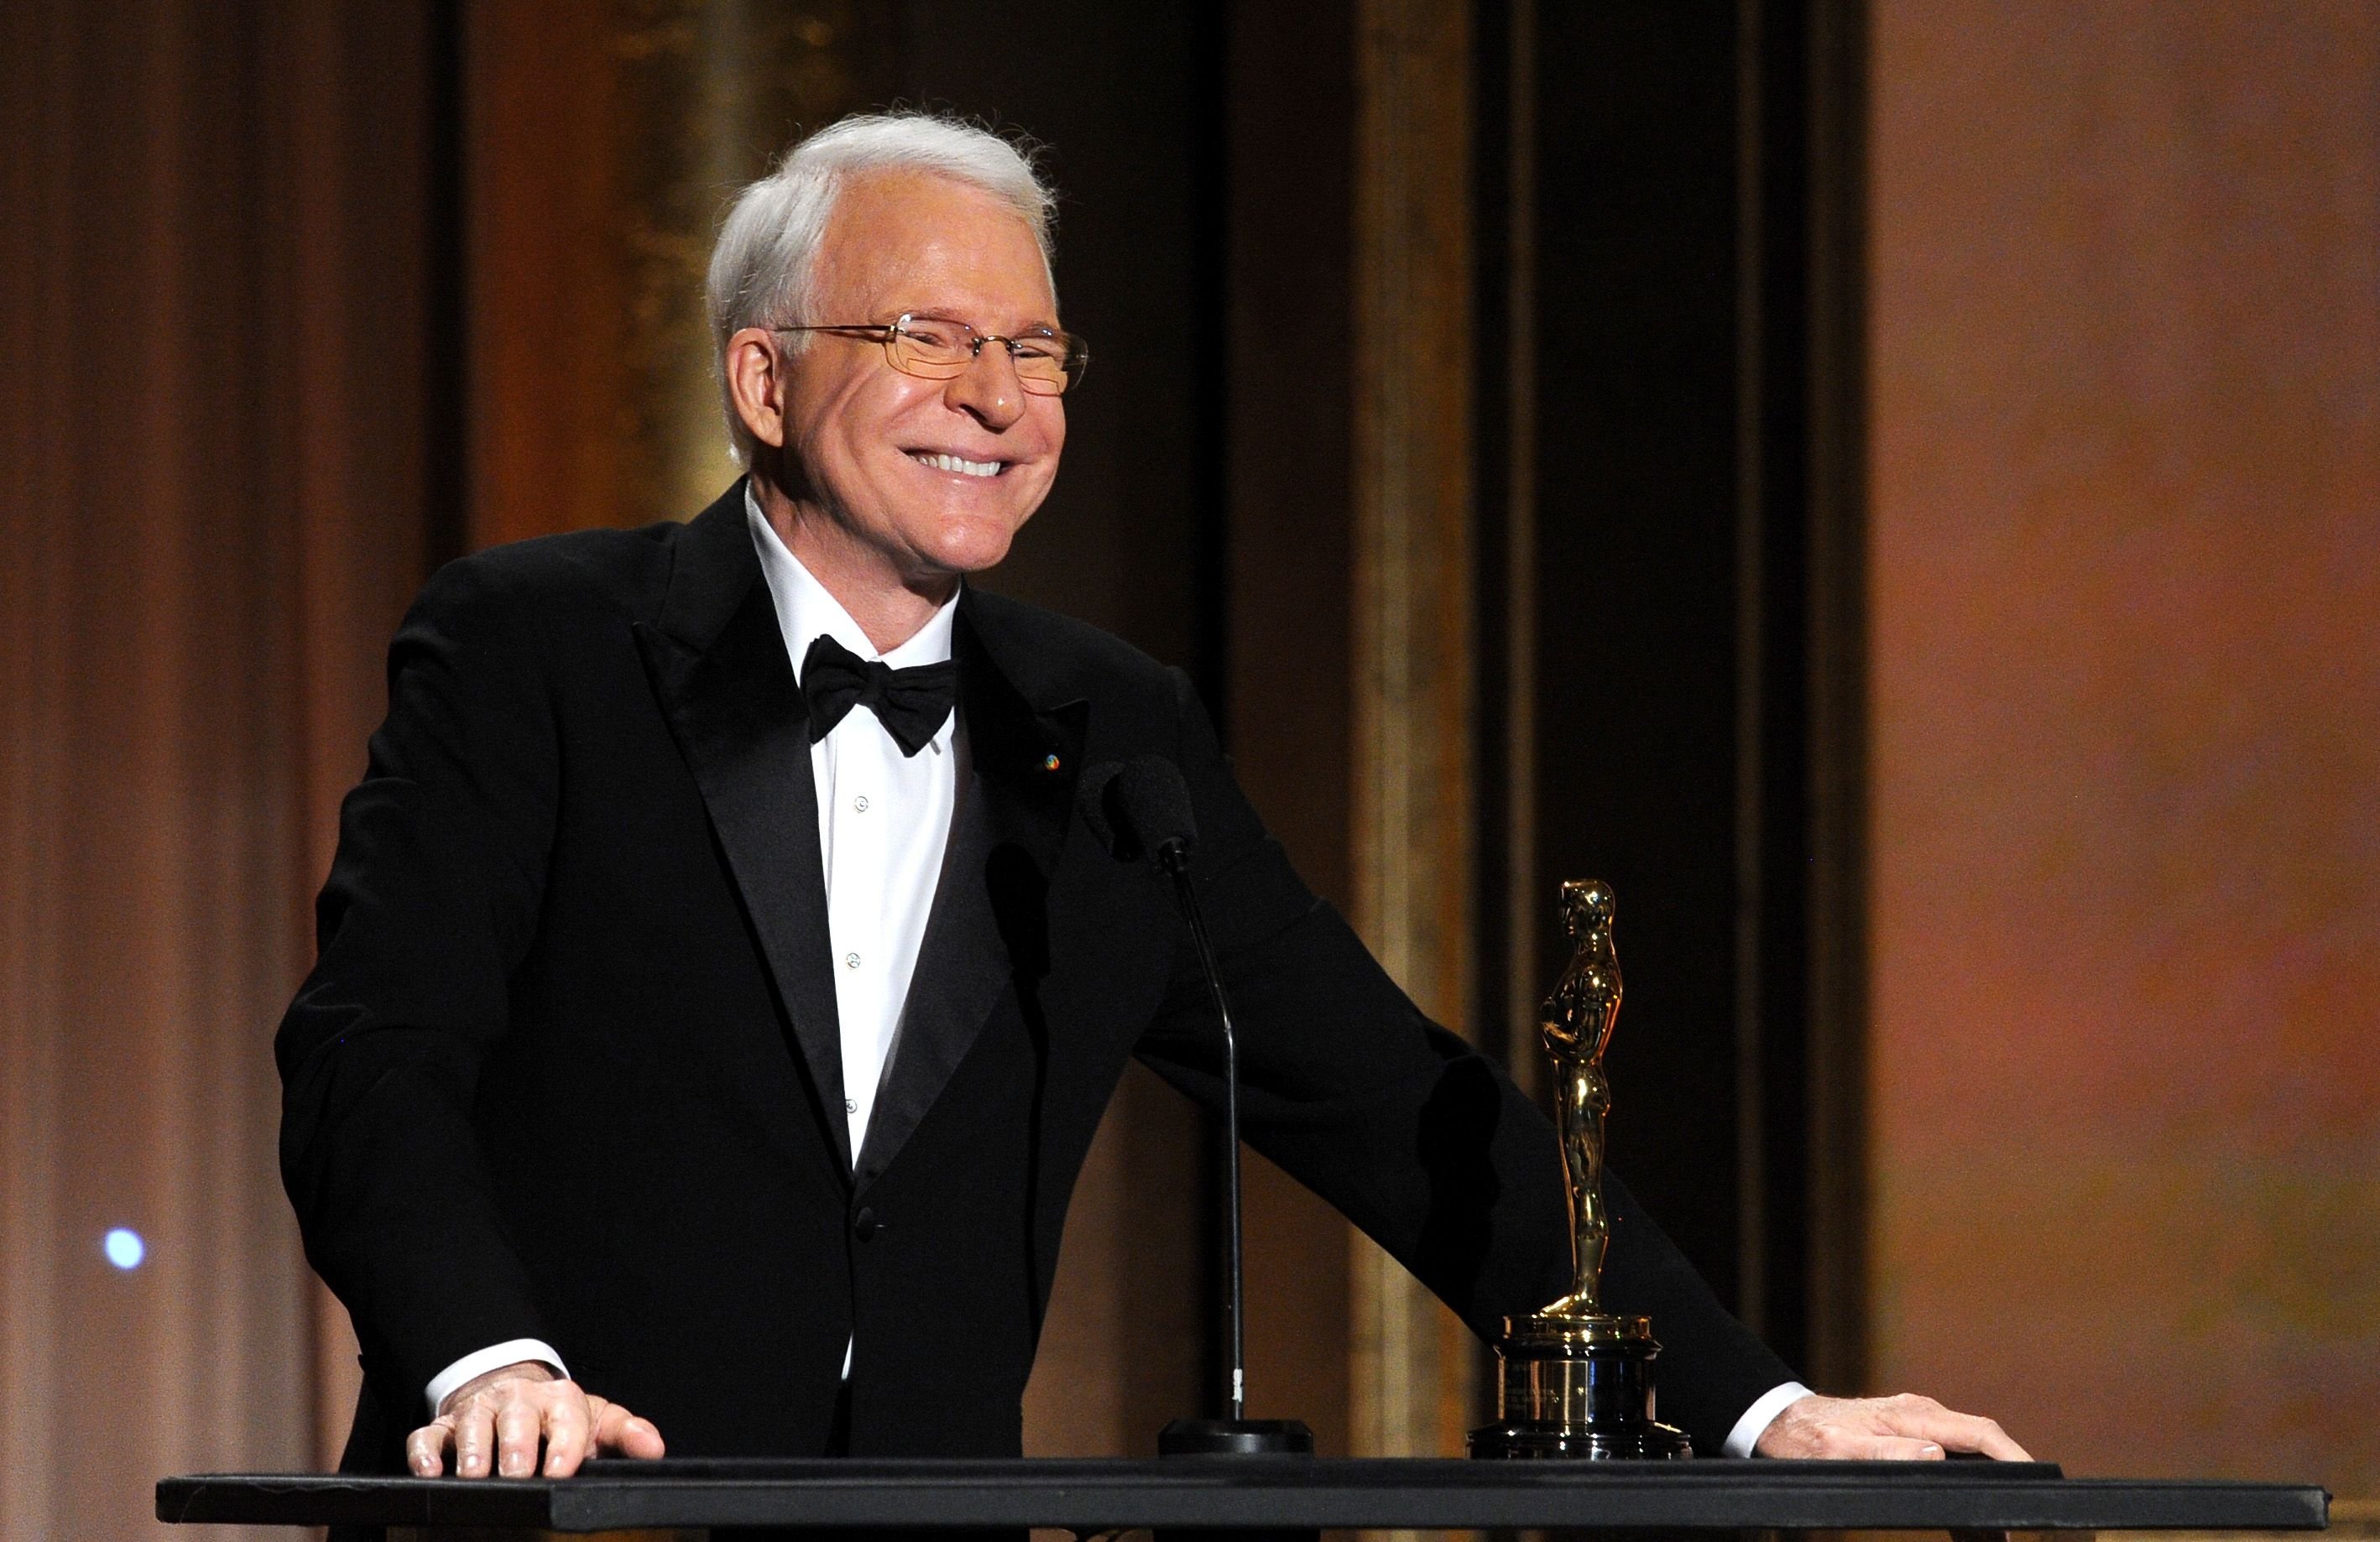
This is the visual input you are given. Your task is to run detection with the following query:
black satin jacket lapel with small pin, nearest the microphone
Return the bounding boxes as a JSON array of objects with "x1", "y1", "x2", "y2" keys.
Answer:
[{"x1": 847, "y1": 602, "x2": 1090, "y2": 1187}]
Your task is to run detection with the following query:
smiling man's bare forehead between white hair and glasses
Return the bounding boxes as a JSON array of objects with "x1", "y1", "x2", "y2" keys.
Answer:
[{"x1": 812, "y1": 171, "x2": 1057, "y2": 333}]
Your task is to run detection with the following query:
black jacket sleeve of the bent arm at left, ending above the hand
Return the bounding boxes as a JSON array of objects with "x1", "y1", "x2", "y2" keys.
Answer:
[{"x1": 274, "y1": 560, "x2": 559, "y2": 1411}]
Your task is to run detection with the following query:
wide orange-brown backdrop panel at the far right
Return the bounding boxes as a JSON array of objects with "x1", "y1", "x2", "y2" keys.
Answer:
[{"x1": 1868, "y1": 0, "x2": 2380, "y2": 1494}]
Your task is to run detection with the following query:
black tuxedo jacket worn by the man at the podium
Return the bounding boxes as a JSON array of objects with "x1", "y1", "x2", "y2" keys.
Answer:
[{"x1": 276, "y1": 486, "x2": 1788, "y2": 1471}]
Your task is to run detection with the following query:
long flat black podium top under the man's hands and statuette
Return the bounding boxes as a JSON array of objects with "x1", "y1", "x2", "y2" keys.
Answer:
[{"x1": 157, "y1": 1456, "x2": 2330, "y2": 1533}]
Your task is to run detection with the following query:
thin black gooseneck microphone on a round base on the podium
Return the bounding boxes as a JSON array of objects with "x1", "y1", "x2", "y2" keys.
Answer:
[{"x1": 1076, "y1": 754, "x2": 1313, "y2": 1456}]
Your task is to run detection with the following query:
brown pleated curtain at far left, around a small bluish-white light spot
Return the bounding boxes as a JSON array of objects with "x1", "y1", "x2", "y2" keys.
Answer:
[{"x1": 0, "y1": 0, "x2": 447, "y2": 1537}]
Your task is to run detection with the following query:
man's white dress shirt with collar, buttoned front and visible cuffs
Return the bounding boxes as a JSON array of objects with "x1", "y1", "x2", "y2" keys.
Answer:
[{"x1": 428, "y1": 494, "x2": 1808, "y2": 1456}]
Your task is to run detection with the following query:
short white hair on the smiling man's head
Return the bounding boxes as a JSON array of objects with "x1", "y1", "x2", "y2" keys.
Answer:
[{"x1": 707, "y1": 112, "x2": 1057, "y2": 466}]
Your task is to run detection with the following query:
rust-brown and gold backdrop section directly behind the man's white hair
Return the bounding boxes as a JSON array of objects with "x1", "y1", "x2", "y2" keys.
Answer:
[{"x1": 459, "y1": 0, "x2": 902, "y2": 545}]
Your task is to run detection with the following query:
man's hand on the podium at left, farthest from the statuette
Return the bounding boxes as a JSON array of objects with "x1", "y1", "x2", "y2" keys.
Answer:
[{"x1": 404, "y1": 1361, "x2": 664, "y2": 1477}]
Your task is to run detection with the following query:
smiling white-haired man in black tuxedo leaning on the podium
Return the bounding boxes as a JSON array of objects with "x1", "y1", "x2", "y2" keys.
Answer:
[{"x1": 276, "y1": 114, "x2": 2021, "y2": 1476}]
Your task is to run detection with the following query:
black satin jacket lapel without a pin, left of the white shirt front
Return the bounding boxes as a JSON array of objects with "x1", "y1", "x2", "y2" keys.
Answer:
[{"x1": 635, "y1": 483, "x2": 852, "y2": 1173}]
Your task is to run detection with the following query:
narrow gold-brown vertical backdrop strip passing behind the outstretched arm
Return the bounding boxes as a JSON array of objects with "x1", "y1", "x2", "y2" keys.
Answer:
[{"x1": 1347, "y1": 0, "x2": 1480, "y2": 1456}]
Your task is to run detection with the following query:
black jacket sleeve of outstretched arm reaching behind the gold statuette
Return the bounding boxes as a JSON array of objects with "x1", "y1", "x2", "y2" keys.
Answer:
[{"x1": 1138, "y1": 676, "x2": 1793, "y2": 1454}]
